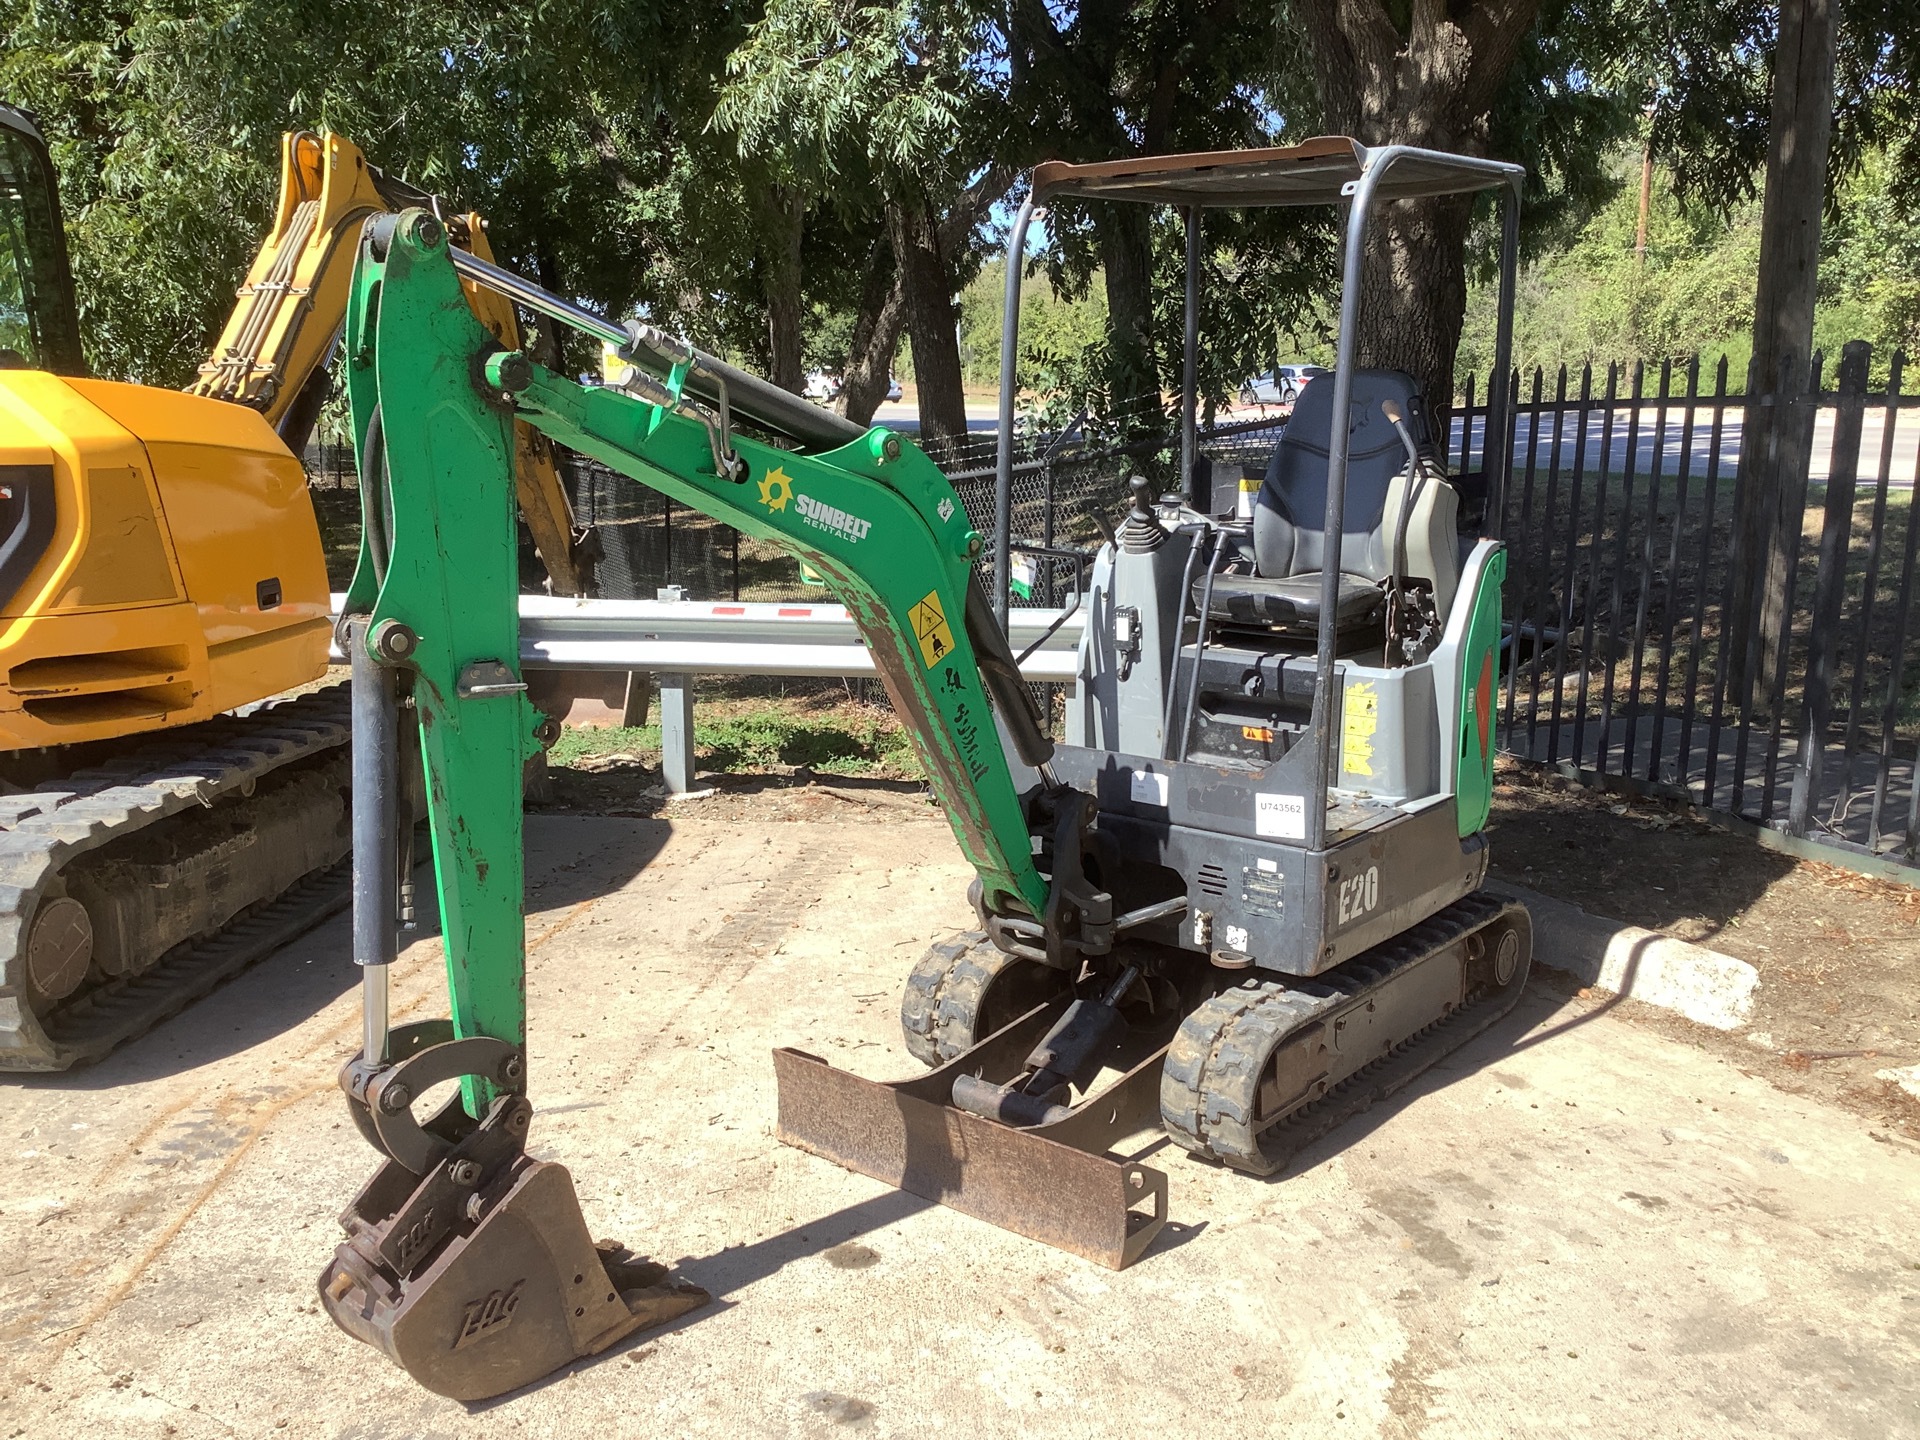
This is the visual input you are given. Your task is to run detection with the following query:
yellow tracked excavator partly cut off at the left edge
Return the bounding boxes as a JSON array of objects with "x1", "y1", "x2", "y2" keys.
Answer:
[{"x1": 0, "y1": 106, "x2": 582, "y2": 1071}]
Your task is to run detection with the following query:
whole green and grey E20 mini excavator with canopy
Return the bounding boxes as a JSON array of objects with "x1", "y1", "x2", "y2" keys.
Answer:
[{"x1": 321, "y1": 138, "x2": 1532, "y2": 1400}]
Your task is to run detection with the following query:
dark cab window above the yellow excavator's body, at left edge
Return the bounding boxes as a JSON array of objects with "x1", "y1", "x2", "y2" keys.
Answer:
[{"x1": 0, "y1": 106, "x2": 83, "y2": 374}]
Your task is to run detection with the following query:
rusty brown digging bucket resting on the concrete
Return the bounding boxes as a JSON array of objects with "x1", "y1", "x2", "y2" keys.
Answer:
[{"x1": 321, "y1": 1105, "x2": 710, "y2": 1400}]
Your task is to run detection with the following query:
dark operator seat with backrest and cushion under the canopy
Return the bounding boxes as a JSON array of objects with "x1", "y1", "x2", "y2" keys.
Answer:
[{"x1": 1196, "y1": 371, "x2": 1457, "y2": 634}]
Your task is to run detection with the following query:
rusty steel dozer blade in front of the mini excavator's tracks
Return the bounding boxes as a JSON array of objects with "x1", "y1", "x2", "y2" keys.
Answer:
[{"x1": 774, "y1": 1002, "x2": 1167, "y2": 1269}]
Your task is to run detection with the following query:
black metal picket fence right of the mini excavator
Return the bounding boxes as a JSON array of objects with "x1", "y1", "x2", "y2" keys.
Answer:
[{"x1": 1474, "y1": 353, "x2": 1920, "y2": 876}]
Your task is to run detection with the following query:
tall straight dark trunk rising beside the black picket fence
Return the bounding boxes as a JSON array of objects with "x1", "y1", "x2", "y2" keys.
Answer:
[{"x1": 1728, "y1": 0, "x2": 1836, "y2": 710}]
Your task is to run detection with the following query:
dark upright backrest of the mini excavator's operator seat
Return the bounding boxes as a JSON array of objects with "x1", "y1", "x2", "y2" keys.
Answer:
[{"x1": 1254, "y1": 371, "x2": 1428, "y2": 580}]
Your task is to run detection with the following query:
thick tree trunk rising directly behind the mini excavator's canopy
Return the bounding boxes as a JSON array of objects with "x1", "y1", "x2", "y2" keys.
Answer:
[{"x1": 1294, "y1": 0, "x2": 1540, "y2": 422}]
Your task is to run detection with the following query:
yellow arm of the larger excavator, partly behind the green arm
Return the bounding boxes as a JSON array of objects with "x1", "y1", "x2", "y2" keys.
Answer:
[{"x1": 190, "y1": 131, "x2": 588, "y2": 595}]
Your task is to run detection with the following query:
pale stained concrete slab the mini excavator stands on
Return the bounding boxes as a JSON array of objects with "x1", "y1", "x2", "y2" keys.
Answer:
[{"x1": 0, "y1": 797, "x2": 1920, "y2": 1440}]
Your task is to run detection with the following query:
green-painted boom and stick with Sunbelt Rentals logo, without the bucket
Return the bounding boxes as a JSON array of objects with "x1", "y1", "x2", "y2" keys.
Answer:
[{"x1": 346, "y1": 211, "x2": 1048, "y2": 1044}]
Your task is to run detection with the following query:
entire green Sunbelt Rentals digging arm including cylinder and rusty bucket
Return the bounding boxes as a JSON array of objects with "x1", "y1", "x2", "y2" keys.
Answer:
[{"x1": 321, "y1": 209, "x2": 1052, "y2": 1400}]
